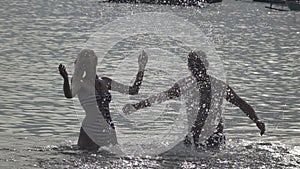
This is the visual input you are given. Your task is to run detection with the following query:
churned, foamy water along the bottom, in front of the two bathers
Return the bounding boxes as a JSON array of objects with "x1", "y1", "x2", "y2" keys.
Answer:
[{"x1": 0, "y1": 137, "x2": 300, "y2": 168}]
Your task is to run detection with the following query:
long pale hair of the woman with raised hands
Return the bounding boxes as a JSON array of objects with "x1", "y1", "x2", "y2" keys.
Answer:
[{"x1": 72, "y1": 49, "x2": 97, "y2": 94}]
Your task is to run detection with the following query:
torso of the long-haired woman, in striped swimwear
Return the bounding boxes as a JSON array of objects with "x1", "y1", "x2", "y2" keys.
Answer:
[{"x1": 78, "y1": 79, "x2": 117, "y2": 145}]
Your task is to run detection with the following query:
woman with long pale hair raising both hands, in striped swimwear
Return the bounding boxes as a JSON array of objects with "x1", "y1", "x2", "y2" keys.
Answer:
[{"x1": 58, "y1": 49, "x2": 148, "y2": 151}]
